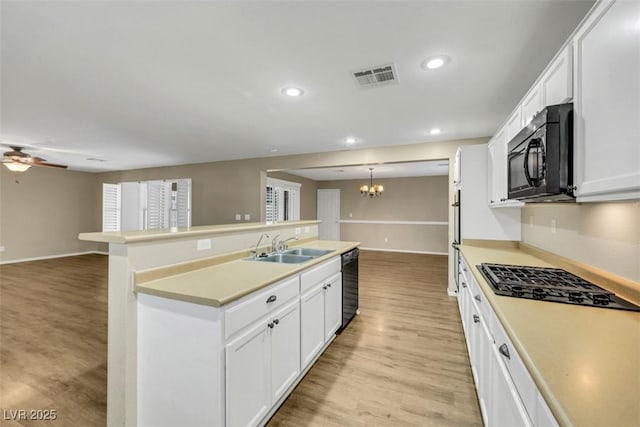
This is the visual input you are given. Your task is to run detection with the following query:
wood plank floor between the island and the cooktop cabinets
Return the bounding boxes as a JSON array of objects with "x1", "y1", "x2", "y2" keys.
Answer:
[{"x1": 269, "y1": 251, "x2": 482, "y2": 427}]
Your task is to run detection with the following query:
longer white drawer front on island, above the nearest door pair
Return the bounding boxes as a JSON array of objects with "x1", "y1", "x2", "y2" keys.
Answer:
[{"x1": 224, "y1": 275, "x2": 300, "y2": 338}]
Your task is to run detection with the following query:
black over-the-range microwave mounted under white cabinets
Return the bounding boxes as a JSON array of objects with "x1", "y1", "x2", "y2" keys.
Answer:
[{"x1": 507, "y1": 103, "x2": 575, "y2": 202}]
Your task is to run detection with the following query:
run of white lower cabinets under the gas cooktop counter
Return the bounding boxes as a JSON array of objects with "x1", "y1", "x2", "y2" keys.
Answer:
[{"x1": 458, "y1": 257, "x2": 558, "y2": 427}]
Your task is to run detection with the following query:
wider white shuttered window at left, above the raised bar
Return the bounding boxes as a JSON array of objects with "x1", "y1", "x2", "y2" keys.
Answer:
[{"x1": 102, "y1": 178, "x2": 191, "y2": 231}]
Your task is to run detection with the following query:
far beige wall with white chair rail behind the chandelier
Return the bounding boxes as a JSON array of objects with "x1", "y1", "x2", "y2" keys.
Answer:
[{"x1": 318, "y1": 176, "x2": 449, "y2": 254}]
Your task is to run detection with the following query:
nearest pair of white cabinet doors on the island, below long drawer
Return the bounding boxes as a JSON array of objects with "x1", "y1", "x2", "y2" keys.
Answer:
[{"x1": 226, "y1": 299, "x2": 300, "y2": 426}]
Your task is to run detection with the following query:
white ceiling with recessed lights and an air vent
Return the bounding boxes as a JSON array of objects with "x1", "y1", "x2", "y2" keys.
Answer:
[{"x1": 0, "y1": 0, "x2": 593, "y2": 171}]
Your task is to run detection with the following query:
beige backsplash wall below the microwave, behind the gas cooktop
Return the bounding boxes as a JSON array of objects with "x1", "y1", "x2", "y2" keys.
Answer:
[{"x1": 522, "y1": 201, "x2": 640, "y2": 283}]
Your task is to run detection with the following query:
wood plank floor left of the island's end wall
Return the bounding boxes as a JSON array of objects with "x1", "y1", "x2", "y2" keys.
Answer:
[{"x1": 0, "y1": 255, "x2": 108, "y2": 427}]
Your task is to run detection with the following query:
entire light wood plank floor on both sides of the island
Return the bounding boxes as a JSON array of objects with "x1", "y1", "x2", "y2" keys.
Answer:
[{"x1": 0, "y1": 251, "x2": 481, "y2": 427}]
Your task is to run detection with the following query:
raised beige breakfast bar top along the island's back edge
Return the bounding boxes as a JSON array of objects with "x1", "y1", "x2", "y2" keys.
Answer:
[{"x1": 78, "y1": 220, "x2": 320, "y2": 243}]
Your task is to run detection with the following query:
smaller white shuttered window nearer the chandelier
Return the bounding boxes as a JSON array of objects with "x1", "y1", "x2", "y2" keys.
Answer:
[{"x1": 265, "y1": 178, "x2": 301, "y2": 222}]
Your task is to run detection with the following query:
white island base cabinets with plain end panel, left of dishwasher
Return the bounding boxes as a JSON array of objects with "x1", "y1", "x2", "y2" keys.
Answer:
[{"x1": 137, "y1": 256, "x2": 342, "y2": 427}]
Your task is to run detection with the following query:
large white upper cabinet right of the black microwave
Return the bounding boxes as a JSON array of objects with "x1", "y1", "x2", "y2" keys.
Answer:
[{"x1": 573, "y1": 1, "x2": 640, "y2": 201}]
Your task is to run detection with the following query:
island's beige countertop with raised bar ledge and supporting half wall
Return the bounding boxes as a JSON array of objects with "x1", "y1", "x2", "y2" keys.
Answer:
[{"x1": 79, "y1": 221, "x2": 357, "y2": 426}]
